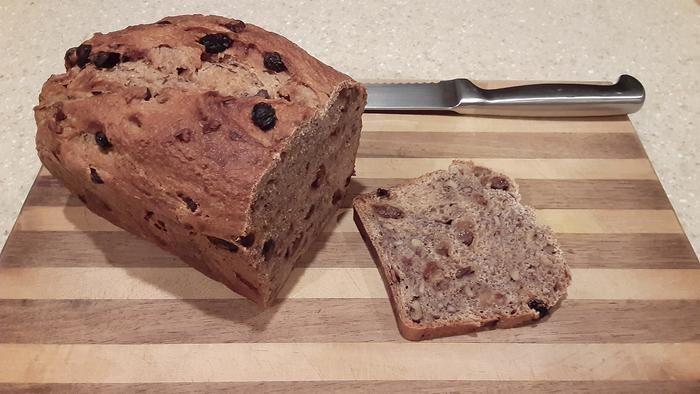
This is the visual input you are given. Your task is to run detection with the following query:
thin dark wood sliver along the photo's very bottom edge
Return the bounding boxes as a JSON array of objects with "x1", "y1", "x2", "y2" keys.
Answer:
[{"x1": 0, "y1": 380, "x2": 700, "y2": 394}]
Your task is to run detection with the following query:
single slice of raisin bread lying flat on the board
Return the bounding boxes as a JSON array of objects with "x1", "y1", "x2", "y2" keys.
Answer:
[{"x1": 353, "y1": 161, "x2": 571, "y2": 340}]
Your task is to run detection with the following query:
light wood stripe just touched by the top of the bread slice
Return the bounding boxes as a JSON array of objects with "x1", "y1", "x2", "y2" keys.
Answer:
[{"x1": 355, "y1": 158, "x2": 657, "y2": 180}]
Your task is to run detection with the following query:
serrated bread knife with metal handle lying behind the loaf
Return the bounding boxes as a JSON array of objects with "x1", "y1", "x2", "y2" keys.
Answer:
[{"x1": 365, "y1": 75, "x2": 645, "y2": 117}]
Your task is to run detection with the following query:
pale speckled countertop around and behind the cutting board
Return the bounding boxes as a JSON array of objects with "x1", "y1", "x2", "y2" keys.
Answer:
[{"x1": 0, "y1": 0, "x2": 700, "y2": 251}]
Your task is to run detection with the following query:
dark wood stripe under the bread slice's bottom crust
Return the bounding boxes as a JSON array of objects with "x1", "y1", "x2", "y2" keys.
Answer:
[{"x1": 0, "y1": 299, "x2": 700, "y2": 344}]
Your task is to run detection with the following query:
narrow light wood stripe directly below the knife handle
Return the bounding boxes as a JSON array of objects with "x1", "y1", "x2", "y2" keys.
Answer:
[{"x1": 362, "y1": 114, "x2": 634, "y2": 135}]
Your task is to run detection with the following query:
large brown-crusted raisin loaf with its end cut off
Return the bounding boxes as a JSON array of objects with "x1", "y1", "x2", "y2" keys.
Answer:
[{"x1": 35, "y1": 15, "x2": 366, "y2": 305}]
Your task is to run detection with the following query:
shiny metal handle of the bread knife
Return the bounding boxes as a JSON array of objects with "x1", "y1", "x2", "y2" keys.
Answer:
[{"x1": 452, "y1": 75, "x2": 644, "y2": 117}]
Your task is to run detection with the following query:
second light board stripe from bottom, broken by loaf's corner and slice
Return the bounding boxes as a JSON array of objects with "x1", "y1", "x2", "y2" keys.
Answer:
[{"x1": 0, "y1": 267, "x2": 700, "y2": 300}]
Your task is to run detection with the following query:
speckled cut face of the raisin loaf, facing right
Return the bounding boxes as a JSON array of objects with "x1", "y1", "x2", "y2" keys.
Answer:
[{"x1": 247, "y1": 83, "x2": 366, "y2": 306}]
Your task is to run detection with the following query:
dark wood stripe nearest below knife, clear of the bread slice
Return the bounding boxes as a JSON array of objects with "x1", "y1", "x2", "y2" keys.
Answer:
[{"x1": 358, "y1": 132, "x2": 646, "y2": 159}]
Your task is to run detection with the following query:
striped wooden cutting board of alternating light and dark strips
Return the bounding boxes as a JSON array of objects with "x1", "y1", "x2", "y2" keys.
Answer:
[{"x1": 0, "y1": 81, "x2": 700, "y2": 393}]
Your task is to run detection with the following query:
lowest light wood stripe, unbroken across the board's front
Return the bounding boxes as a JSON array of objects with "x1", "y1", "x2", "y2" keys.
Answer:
[{"x1": 0, "y1": 343, "x2": 700, "y2": 383}]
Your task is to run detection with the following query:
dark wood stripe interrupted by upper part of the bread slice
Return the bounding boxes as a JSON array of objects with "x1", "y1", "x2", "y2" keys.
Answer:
[{"x1": 27, "y1": 177, "x2": 671, "y2": 209}]
